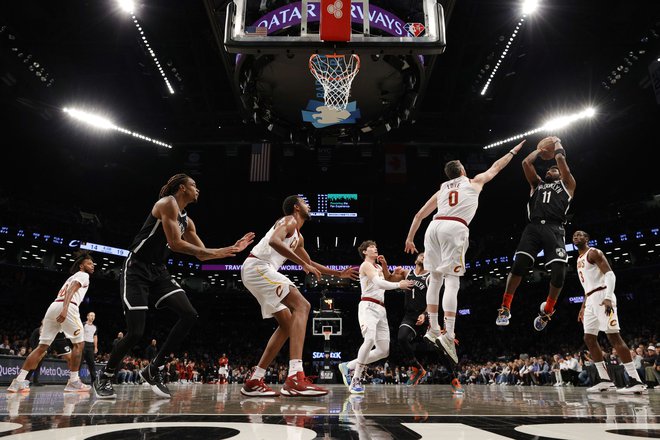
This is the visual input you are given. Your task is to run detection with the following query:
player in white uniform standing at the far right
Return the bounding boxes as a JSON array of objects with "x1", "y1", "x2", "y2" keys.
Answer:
[{"x1": 573, "y1": 231, "x2": 647, "y2": 394}]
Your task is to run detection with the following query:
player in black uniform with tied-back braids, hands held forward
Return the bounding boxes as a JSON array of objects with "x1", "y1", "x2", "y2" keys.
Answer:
[{"x1": 94, "y1": 174, "x2": 254, "y2": 399}]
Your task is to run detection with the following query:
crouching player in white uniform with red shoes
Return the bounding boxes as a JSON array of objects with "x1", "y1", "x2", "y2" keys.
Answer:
[{"x1": 241, "y1": 196, "x2": 357, "y2": 397}]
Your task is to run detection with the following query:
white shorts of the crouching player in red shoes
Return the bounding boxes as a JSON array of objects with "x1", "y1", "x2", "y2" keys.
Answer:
[{"x1": 241, "y1": 257, "x2": 295, "y2": 319}]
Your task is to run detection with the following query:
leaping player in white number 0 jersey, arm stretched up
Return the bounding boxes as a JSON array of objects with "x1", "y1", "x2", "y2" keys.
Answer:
[{"x1": 405, "y1": 141, "x2": 525, "y2": 363}]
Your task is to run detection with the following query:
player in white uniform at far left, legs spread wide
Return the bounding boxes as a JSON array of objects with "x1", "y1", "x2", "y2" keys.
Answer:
[{"x1": 7, "y1": 253, "x2": 94, "y2": 393}]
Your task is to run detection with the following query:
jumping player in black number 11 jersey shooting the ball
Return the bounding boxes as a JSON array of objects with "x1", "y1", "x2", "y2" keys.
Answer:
[{"x1": 495, "y1": 136, "x2": 575, "y2": 331}]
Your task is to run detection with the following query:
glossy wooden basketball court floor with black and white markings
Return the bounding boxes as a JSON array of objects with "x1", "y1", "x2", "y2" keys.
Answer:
[{"x1": 0, "y1": 384, "x2": 660, "y2": 440}]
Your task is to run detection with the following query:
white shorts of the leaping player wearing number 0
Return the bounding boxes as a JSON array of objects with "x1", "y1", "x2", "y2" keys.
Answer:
[{"x1": 424, "y1": 220, "x2": 470, "y2": 276}]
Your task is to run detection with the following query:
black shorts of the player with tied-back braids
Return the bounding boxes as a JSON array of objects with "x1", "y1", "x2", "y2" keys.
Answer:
[{"x1": 119, "y1": 254, "x2": 185, "y2": 310}]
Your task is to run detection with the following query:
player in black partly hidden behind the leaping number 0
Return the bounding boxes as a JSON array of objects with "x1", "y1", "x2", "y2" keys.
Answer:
[{"x1": 378, "y1": 252, "x2": 431, "y2": 385}]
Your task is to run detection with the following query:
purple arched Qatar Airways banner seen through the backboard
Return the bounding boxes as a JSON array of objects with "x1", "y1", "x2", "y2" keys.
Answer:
[{"x1": 252, "y1": 2, "x2": 416, "y2": 37}]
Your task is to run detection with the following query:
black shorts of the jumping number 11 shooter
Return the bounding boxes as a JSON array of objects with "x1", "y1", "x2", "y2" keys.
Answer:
[{"x1": 516, "y1": 223, "x2": 568, "y2": 266}]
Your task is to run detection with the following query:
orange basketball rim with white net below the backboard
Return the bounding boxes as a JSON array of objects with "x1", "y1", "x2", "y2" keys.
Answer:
[{"x1": 309, "y1": 54, "x2": 360, "y2": 111}]
